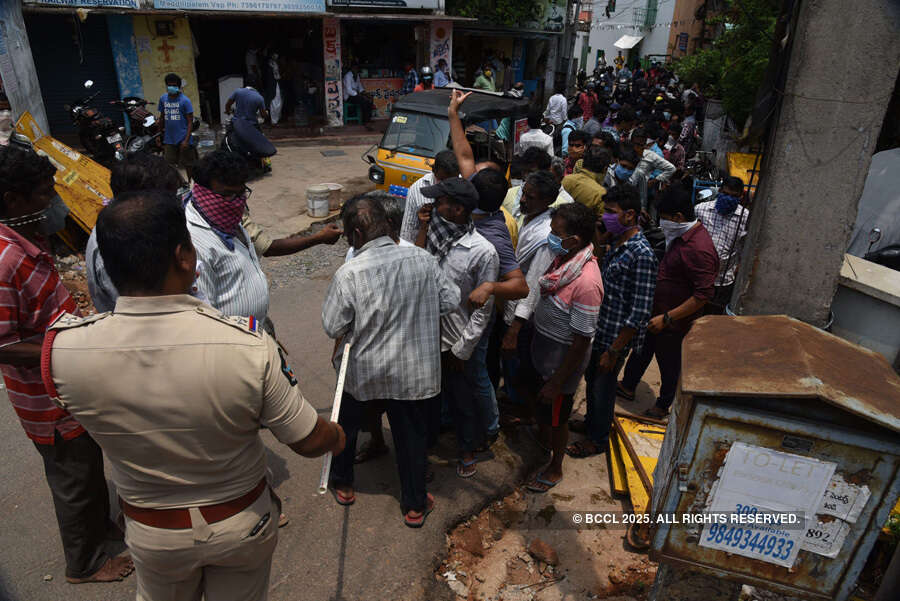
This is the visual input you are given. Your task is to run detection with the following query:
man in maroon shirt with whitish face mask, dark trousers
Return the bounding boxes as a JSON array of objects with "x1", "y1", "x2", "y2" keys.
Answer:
[{"x1": 619, "y1": 185, "x2": 719, "y2": 418}]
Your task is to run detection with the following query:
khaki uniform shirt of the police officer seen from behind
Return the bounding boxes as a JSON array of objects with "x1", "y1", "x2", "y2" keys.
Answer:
[{"x1": 44, "y1": 295, "x2": 317, "y2": 508}]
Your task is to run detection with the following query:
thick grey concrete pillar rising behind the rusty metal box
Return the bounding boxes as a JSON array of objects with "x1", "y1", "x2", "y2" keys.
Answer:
[{"x1": 731, "y1": 0, "x2": 900, "y2": 326}]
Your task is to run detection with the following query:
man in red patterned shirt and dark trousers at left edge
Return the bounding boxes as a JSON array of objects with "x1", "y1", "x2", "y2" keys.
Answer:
[{"x1": 0, "y1": 146, "x2": 134, "y2": 584}]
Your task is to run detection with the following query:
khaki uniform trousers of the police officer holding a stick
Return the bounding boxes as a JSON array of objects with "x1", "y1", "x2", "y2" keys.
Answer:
[{"x1": 125, "y1": 490, "x2": 279, "y2": 601}]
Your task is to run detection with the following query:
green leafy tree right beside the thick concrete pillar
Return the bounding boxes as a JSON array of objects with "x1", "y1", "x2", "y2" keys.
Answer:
[{"x1": 675, "y1": 0, "x2": 781, "y2": 124}]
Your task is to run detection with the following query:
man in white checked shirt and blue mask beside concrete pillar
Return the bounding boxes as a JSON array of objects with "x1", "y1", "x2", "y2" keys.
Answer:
[{"x1": 694, "y1": 176, "x2": 750, "y2": 314}]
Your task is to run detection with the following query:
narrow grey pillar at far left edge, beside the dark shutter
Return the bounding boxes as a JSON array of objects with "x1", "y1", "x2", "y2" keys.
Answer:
[{"x1": 0, "y1": 0, "x2": 50, "y2": 134}]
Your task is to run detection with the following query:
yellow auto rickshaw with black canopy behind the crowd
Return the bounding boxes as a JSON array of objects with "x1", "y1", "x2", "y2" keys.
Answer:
[{"x1": 363, "y1": 87, "x2": 530, "y2": 197}]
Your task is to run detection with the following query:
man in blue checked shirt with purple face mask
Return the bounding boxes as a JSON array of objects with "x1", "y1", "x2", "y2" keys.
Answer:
[{"x1": 566, "y1": 184, "x2": 658, "y2": 457}]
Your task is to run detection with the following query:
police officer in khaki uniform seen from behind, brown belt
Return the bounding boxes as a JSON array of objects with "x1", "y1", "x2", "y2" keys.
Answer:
[{"x1": 42, "y1": 191, "x2": 345, "y2": 601}]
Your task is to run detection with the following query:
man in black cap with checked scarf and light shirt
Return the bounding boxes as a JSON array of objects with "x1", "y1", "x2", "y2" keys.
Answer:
[{"x1": 416, "y1": 177, "x2": 500, "y2": 478}]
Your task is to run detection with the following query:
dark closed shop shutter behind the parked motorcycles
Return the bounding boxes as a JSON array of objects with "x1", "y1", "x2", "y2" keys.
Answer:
[{"x1": 25, "y1": 13, "x2": 123, "y2": 141}]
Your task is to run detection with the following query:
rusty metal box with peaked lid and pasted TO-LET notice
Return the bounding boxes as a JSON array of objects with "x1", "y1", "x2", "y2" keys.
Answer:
[{"x1": 650, "y1": 316, "x2": 900, "y2": 601}]
